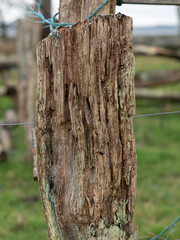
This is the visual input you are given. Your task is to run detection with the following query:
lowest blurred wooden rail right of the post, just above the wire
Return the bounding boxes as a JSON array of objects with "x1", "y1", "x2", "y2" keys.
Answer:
[{"x1": 136, "y1": 88, "x2": 180, "y2": 101}]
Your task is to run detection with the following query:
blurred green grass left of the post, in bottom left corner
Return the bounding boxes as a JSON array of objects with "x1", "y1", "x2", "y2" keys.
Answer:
[{"x1": 0, "y1": 157, "x2": 47, "y2": 240}]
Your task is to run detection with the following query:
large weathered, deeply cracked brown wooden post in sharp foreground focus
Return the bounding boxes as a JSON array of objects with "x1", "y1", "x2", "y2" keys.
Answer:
[{"x1": 36, "y1": 14, "x2": 137, "y2": 240}]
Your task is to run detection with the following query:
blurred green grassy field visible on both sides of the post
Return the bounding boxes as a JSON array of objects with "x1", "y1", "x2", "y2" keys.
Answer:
[{"x1": 0, "y1": 57, "x2": 180, "y2": 240}]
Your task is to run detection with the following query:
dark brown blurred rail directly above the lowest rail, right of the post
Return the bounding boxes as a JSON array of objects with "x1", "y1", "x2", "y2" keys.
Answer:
[{"x1": 135, "y1": 70, "x2": 180, "y2": 87}]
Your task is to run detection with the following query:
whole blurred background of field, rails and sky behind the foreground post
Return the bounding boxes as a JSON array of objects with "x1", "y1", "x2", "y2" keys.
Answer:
[{"x1": 0, "y1": 0, "x2": 180, "y2": 240}]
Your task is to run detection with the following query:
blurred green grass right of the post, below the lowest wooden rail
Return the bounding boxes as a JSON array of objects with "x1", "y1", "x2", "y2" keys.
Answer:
[{"x1": 134, "y1": 100, "x2": 180, "y2": 239}]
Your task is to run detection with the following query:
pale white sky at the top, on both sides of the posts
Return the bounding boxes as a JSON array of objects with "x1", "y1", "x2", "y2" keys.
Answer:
[{"x1": 0, "y1": 0, "x2": 178, "y2": 27}]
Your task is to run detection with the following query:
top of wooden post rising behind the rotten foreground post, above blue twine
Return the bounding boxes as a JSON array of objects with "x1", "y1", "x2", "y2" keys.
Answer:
[{"x1": 59, "y1": 0, "x2": 116, "y2": 23}]
